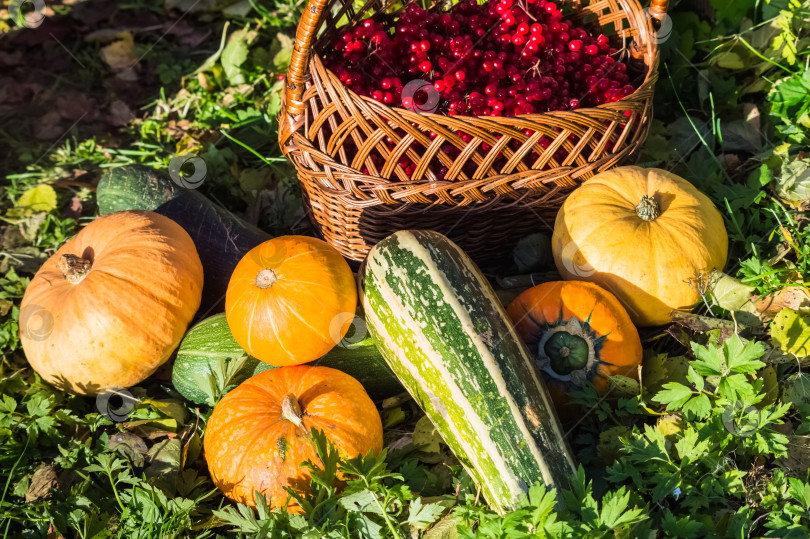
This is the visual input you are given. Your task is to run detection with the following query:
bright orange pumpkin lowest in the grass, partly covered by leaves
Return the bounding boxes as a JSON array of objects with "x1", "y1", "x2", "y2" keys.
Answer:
[{"x1": 204, "y1": 365, "x2": 382, "y2": 512}]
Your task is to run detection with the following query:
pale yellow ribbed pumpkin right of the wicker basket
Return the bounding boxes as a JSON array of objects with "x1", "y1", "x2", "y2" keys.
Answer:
[{"x1": 552, "y1": 166, "x2": 728, "y2": 326}]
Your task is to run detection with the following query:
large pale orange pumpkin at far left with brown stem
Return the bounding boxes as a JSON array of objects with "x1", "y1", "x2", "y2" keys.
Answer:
[{"x1": 20, "y1": 211, "x2": 203, "y2": 395}]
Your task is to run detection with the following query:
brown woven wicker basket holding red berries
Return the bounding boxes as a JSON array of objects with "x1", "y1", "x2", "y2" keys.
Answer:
[{"x1": 279, "y1": 0, "x2": 667, "y2": 263}]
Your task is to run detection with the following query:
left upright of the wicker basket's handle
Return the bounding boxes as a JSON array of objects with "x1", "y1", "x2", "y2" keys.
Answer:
[{"x1": 284, "y1": 0, "x2": 329, "y2": 116}]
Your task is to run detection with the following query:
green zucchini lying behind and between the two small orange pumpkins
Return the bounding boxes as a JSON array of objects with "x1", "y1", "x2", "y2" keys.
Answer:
[{"x1": 172, "y1": 313, "x2": 402, "y2": 404}]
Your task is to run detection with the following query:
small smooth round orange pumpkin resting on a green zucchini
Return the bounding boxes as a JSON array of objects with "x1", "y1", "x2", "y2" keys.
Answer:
[{"x1": 225, "y1": 236, "x2": 357, "y2": 367}]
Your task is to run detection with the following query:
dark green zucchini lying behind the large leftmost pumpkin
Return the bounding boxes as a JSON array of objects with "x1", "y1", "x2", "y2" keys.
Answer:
[{"x1": 96, "y1": 165, "x2": 272, "y2": 317}]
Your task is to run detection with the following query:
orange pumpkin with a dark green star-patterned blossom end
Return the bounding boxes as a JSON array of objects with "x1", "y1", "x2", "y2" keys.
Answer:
[{"x1": 507, "y1": 281, "x2": 641, "y2": 408}]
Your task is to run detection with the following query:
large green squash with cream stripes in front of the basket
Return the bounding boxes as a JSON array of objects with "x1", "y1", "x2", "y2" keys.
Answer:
[{"x1": 362, "y1": 231, "x2": 576, "y2": 513}]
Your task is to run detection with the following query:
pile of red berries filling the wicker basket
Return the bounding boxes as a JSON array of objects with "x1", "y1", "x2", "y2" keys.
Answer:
[{"x1": 324, "y1": 0, "x2": 635, "y2": 116}]
